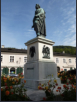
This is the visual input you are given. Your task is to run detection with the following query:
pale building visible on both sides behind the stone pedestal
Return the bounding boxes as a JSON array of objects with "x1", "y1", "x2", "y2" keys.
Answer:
[{"x1": 1, "y1": 47, "x2": 76, "y2": 74}]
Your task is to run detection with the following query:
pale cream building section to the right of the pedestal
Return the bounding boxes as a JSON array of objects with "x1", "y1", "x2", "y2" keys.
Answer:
[{"x1": 54, "y1": 52, "x2": 76, "y2": 71}]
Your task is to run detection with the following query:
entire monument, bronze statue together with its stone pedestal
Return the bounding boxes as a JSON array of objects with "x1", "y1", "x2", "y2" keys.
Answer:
[{"x1": 24, "y1": 4, "x2": 61, "y2": 89}]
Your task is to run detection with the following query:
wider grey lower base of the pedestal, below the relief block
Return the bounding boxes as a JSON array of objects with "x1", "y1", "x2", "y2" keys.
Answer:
[{"x1": 24, "y1": 61, "x2": 61, "y2": 89}]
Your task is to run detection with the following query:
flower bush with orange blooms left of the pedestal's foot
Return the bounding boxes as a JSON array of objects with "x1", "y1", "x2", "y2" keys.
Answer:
[{"x1": 1, "y1": 73, "x2": 30, "y2": 101}]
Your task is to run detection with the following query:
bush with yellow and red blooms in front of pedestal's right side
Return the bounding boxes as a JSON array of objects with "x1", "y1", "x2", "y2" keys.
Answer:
[{"x1": 38, "y1": 75, "x2": 58, "y2": 101}]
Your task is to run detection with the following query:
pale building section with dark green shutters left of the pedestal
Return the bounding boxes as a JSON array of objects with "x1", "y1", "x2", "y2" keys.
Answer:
[{"x1": 1, "y1": 48, "x2": 27, "y2": 74}]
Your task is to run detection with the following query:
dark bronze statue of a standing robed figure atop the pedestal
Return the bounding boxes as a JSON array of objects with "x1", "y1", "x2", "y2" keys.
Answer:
[{"x1": 32, "y1": 4, "x2": 46, "y2": 37}]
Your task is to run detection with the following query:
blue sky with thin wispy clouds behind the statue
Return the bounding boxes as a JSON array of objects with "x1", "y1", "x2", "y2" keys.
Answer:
[{"x1": 1, "y1": 0, "x2": 76, "y2": 49}]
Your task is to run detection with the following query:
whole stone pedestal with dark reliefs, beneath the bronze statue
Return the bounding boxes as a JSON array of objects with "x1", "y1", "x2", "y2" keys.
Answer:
[{"x1": 24, "y1": 37, "x2": 61, "y2": 89}]
